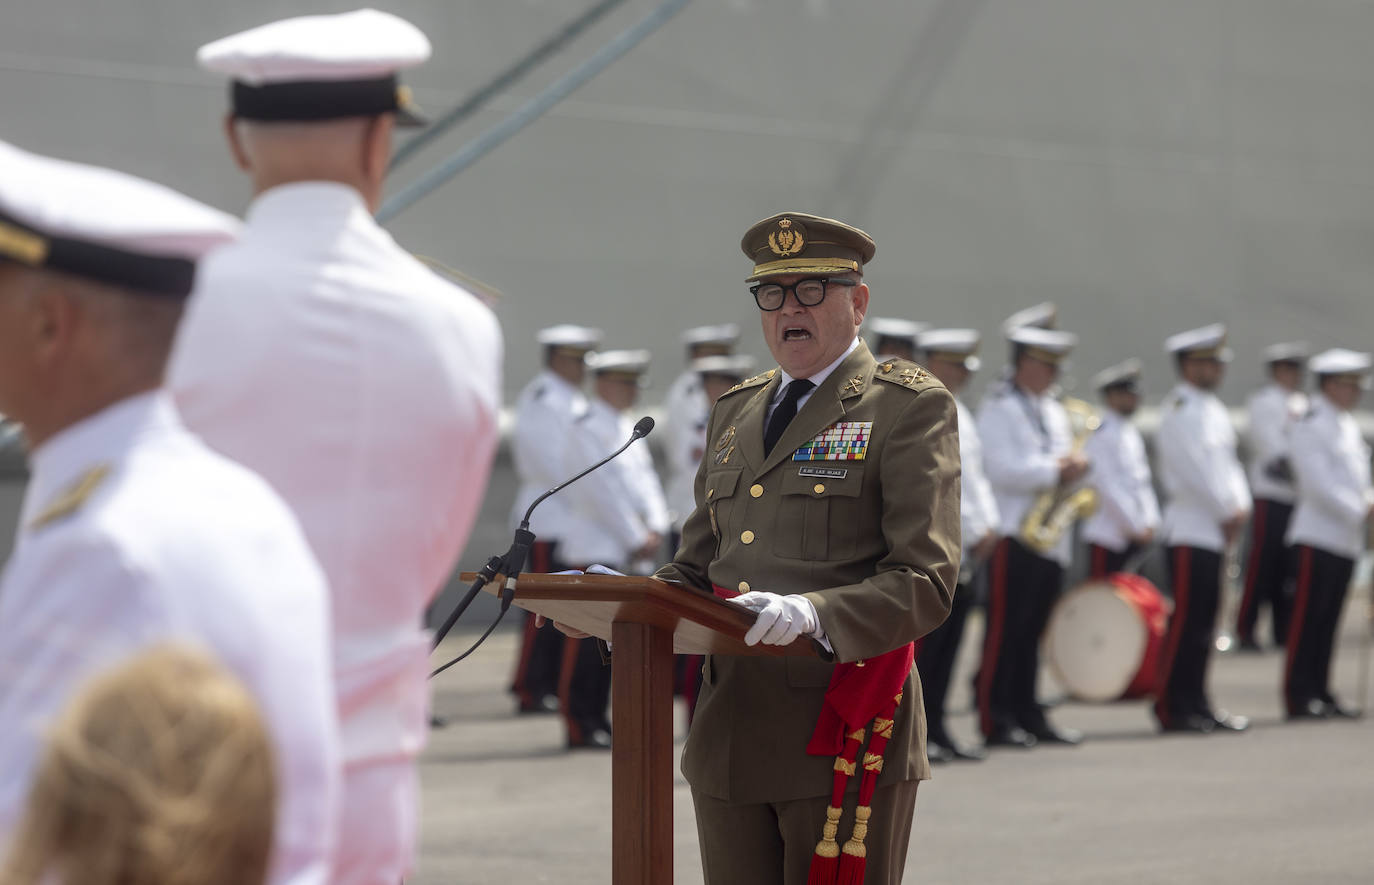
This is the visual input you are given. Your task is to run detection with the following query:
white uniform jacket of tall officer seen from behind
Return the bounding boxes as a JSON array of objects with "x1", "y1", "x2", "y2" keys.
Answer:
[{"x1": 169, "y1": 181, "x2": 502, "y2": 882}]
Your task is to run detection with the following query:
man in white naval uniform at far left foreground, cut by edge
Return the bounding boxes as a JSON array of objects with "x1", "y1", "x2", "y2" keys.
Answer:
[{"x1": 0, "y1": 143, "x2": 339, "y2": 885}]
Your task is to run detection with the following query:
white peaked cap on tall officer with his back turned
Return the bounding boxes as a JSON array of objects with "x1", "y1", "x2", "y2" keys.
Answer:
[{"x1": 195, "y1": 10, "x2": 430, "y2": 125}]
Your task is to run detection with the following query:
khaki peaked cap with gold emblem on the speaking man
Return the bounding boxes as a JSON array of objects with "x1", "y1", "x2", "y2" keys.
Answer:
[{"x1": 739, "y1": 212, "x2": 878, "y2": 283}]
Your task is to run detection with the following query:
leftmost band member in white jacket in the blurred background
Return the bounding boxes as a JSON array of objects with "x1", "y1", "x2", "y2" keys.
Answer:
[{"x1": 511, "y1": 323, "x2": 602, "y2": 713}]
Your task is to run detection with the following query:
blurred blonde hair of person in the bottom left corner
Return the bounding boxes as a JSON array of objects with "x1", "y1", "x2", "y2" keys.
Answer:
[{"x1": 0, "y1": 646, "x2": 276, "y2": 885}]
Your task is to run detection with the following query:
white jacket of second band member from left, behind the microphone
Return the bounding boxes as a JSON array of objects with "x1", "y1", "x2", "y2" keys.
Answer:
[{"x1": 562, "y1": 397, "x2": 668, "y2": 566}]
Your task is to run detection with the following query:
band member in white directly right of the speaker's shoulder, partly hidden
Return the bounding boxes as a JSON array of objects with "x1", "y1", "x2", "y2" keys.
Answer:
[{"x1": 916, "y1": 328, "x2": 1002, "y2": 763}]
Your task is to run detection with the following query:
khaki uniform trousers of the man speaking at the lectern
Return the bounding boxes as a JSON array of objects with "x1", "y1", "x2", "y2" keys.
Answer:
[{"x1": 691, "y1": 781, "x2": 921, "y2": 885}]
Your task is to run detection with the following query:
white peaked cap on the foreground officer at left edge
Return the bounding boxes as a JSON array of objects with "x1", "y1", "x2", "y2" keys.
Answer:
[{"x1": 0, "y1": 142, "x2": 239, "y2": 297}]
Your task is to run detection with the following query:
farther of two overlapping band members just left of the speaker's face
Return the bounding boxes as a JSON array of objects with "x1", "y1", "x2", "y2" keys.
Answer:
[{"x1": 660, "y1": 323, "x2": 739, "y2": 550}]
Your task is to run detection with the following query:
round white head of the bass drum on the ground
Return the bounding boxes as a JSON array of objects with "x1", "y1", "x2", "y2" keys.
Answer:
[{"x1": 1044, "y1": 581, "x2": 1150, "y2": 701}]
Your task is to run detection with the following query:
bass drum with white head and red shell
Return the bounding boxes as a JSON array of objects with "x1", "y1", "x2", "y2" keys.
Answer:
[{"x1": 1044, "y1": 572, "x2": 1172, "y2": 701}]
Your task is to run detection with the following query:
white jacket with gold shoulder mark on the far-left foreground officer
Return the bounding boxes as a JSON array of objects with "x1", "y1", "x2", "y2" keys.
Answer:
[{"x1": 0, "y1": 393, "x2": 339, "y2": 885}]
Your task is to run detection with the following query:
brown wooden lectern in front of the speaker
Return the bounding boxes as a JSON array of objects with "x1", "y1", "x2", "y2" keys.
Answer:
[{"x1": 472, "y1": 573, "x2": 816, "y2": 885}]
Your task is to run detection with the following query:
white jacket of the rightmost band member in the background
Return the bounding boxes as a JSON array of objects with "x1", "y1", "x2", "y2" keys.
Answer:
[{"x1": 1286, "y1": 394, "x2": 1374, "y2": 559}]
